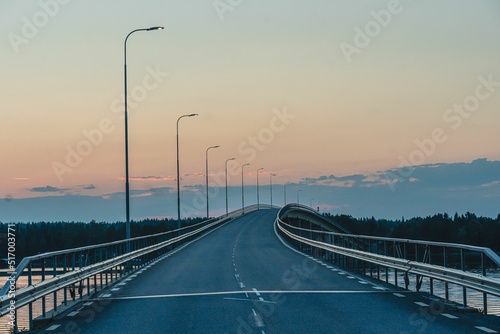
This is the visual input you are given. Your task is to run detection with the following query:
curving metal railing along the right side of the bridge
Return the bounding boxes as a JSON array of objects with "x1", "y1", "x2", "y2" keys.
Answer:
[{"x1": 276, "y1": 205, "x2": 500, "y2": 313}]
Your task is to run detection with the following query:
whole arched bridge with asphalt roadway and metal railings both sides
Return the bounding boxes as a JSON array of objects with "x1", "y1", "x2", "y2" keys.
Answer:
[{"x1": 0, "y1": 204, "x2": 500, "y2": 334}]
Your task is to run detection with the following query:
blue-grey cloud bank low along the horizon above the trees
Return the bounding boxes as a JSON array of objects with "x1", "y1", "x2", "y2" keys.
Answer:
[{"x1": 7, "y1": 159, "x2": 500, "y2": 221}]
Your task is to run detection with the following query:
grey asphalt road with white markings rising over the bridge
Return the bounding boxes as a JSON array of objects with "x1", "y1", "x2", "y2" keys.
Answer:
[{"x1": 39, "y1": 210, "x2": 500, "y2": 334}]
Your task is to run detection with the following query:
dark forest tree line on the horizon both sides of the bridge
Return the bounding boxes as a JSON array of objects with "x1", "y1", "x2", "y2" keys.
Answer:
[{"x1": 0, "y1": 212, "x2": 500, "y2": 262}]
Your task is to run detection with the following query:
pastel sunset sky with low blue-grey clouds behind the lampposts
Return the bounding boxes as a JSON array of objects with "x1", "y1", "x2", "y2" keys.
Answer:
[{"x1": 0, "y1": 0, "x2": 500, "y2": 221}]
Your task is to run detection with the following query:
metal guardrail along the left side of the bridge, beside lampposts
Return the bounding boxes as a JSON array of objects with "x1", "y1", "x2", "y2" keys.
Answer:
[{"x1": 0, "y1": 205, "x2": 270, "y2": 332}]
